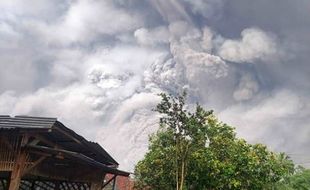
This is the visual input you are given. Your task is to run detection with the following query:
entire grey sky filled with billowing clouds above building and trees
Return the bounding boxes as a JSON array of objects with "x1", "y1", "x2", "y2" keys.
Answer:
[{"x1": 0, "y1": 0, "x2": 310, "y2": 171}]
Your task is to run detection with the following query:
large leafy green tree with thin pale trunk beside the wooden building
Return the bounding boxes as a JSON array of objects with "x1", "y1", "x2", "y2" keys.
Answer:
[{"x1": 135, "y1": 93, "x2": 294, "y2": 190}]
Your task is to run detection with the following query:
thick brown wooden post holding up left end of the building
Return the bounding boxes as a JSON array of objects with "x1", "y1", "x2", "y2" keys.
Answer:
[{"x1": 9, "y1": 150, "x2": 27, "y2": 190}]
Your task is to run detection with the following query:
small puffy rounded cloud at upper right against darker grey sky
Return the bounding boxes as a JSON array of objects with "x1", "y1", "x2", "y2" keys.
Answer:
[{"x1": 218, "y1": 28, "x2": 277, "y2": 63}]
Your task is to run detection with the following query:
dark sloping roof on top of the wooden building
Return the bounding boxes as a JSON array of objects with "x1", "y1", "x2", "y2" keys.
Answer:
[{"x1": 0, "y1": 115, "x2": 127, "y2": 175}]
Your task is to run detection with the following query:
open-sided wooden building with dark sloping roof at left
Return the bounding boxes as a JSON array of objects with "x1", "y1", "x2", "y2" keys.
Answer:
[{"x1": 0, "y1": 116, "x2": 129, "y2": 190}]
